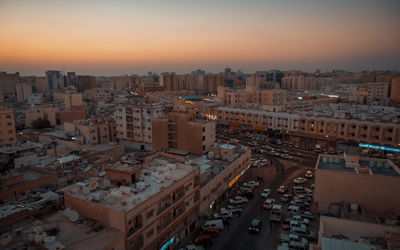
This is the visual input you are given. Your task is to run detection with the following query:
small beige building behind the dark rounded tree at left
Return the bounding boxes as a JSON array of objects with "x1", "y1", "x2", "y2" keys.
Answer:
[{"x1": 25, "y1": 105, "x2": 59, "y2": 127}]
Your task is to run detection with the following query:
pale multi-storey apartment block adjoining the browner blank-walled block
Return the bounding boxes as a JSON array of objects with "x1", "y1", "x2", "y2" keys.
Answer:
[{"x1": 114, "y1": 98, "x2": 165, "y2": 144}]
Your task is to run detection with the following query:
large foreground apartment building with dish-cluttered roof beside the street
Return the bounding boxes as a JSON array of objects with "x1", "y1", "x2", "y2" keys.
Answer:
[{"x1": 64, "y1": 153, "x2": 200, "y2": 250}]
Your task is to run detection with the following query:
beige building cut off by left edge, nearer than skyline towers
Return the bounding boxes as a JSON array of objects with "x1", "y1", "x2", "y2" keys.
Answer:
[{"x1": 0, "y1": 104, "x2": 17, "y2": 145}]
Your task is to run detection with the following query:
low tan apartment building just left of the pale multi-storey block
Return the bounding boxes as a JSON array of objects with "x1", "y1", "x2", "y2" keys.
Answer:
[{"x1": 64, "y1": 117, "x2": 116, "y2": 145}]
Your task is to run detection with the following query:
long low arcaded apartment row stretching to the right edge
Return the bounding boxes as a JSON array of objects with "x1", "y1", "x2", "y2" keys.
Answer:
[{"x1": 210, "y1": 105, "x2": 400, "y2": 147}]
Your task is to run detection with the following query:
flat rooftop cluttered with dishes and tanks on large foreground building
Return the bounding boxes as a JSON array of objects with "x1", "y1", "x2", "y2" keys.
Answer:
[{"x1": 65, "y1": 156, "x2": 196, "y2": 212}]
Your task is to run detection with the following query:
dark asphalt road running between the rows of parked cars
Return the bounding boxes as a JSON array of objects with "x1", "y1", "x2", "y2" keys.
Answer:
[{"x1": 209, "y1": 164, "x2": 304, "y2": 250}]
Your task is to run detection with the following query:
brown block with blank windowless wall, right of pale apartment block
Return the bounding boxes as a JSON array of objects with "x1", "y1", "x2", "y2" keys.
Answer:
[{"x1": 153, "y1": 112, "x2": 215, "y2": 155}]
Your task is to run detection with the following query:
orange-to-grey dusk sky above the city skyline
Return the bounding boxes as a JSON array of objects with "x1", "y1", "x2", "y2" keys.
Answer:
[{"x1": 0, "y1": 0, "x2": 400, "y2": 75}]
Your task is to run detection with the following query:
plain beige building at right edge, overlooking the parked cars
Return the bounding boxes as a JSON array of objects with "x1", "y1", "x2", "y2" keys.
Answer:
[{"x1": 314, "y1": 153, "x2": 400, "y2": 216}]
